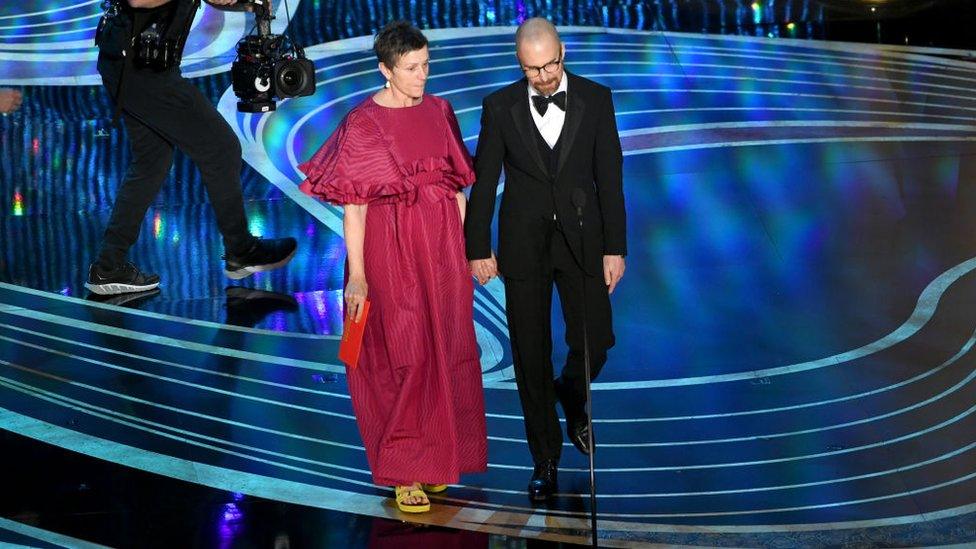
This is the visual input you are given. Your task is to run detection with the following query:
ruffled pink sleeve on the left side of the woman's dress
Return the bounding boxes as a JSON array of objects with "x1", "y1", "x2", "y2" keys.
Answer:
[{"x1": 298, "y1": 109, "x2": 405, "y2": 205}]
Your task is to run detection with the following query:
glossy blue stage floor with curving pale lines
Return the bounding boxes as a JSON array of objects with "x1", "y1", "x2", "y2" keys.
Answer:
[{"x1": 0, "y1": 20, "x2": 976, "y2": 547}]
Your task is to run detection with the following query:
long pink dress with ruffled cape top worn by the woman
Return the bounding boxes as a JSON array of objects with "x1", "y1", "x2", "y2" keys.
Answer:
[{"x1": 299, "y1": 95, "x2": 487, "y2": 486}]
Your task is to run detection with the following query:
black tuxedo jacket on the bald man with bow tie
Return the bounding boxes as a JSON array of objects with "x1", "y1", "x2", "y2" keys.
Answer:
[{"x1": 464, "y1": 71, "x2": 627, "y2": 278}]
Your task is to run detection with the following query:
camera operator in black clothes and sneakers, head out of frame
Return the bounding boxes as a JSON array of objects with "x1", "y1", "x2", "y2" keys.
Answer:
[{"x1": 85, "y1": 0, "x2": 296, "y2": 295}]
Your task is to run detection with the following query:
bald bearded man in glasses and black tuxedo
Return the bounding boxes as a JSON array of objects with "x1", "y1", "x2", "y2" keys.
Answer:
[{"x1": 464, "y1": 18, "x2": 627, "y2": 501}]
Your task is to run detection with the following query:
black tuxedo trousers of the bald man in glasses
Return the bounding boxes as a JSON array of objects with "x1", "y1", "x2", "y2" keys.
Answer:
[{"x1": 505, "y1": 223, "x2": 614, "y2": 463}]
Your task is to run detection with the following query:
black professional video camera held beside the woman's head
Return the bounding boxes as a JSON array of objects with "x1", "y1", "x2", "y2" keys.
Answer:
[{"x1": 230, "y1": 0, "x2": 315, "y2": 112}]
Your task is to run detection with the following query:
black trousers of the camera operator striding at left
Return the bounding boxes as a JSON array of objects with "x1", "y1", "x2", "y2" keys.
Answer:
[{"x1": 98, "y1": 57, "x2": 254, "y2": 268}]
